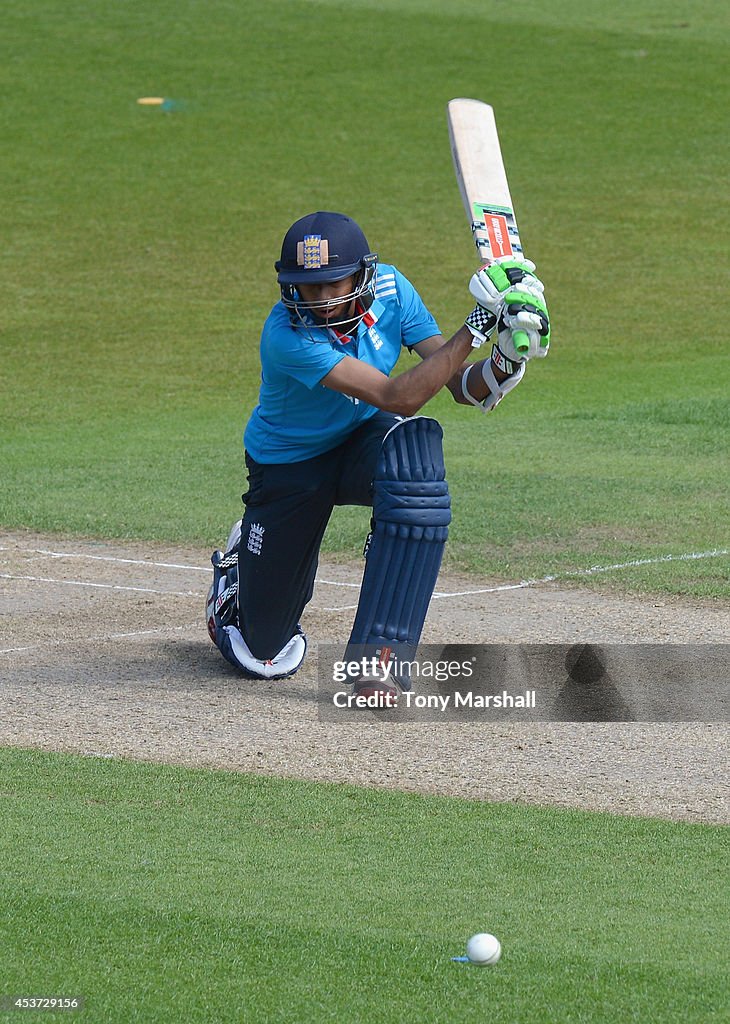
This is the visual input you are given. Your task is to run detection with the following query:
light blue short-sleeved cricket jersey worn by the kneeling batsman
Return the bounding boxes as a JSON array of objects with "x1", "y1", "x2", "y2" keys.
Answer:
[{"x1": 244, "y1": 263, "x2": 440, "y2": 463}]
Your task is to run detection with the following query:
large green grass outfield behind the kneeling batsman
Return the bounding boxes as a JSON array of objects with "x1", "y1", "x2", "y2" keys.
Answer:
[{"x1": 0, "y1": 0, "x2": 730, "y2": 596}]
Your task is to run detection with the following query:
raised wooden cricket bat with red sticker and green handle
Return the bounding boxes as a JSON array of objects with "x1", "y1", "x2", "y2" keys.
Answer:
[{"x1": 446, "y1": 98, "x2": 529, "y2": 352}]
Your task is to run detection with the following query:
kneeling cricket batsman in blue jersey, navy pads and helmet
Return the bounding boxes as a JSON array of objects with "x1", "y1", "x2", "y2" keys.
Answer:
[{"x1": 207, "y1": 211, "x2": 550, "y2": 707}]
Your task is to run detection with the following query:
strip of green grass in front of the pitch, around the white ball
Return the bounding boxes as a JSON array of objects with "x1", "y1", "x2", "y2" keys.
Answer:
[{"x1": 0, "y1": 751, "x2": 730, "y2": 1024}]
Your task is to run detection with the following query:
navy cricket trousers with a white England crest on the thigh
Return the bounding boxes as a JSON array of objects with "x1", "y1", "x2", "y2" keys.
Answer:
[{"x1": 239, "y1": 412, "x2": 400, "y2": 659}]
